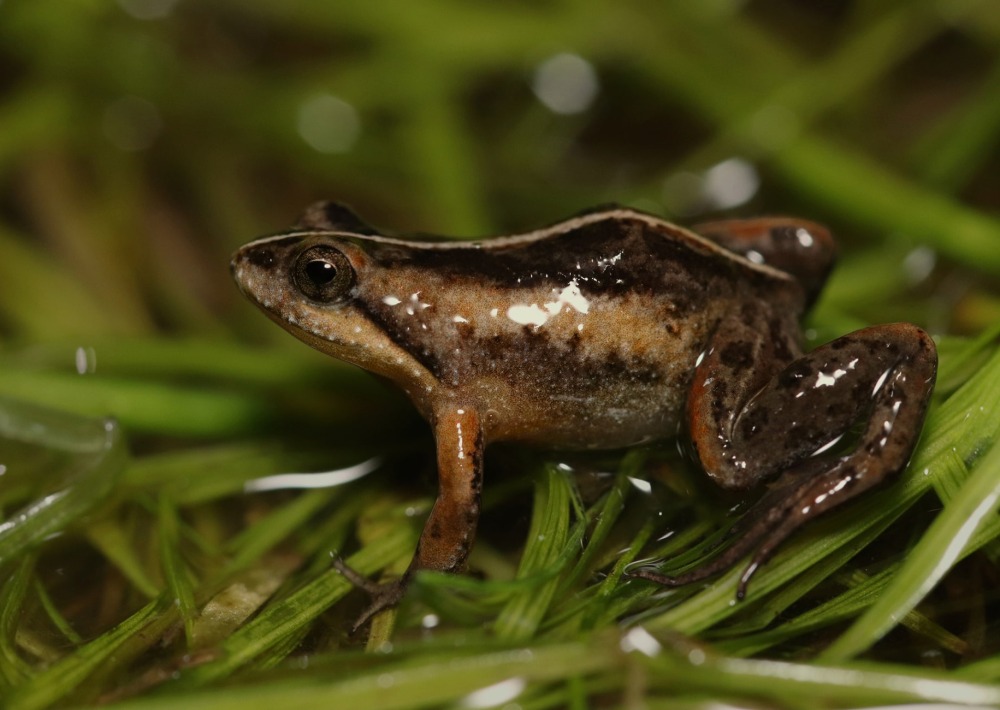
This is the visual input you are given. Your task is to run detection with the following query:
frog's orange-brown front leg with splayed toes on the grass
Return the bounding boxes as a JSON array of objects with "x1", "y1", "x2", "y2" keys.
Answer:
[{"x1": 336, "y1": 406, "x2": 485, "y2": 629}]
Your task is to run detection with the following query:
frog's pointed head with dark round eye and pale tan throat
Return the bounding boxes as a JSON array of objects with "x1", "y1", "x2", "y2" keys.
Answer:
[{"x1": 230, "y1": 231, "x2": 434, "y2": 394}]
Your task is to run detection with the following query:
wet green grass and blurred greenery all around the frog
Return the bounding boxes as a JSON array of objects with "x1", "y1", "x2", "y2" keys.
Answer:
[{"x1": 0, "y1": 0, "x2": 1000, "y2": 710}]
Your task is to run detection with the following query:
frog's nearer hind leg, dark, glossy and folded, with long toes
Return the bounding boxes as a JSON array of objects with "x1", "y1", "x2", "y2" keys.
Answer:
[{"x1": 634, "y1": 318, "x2": 937, "y2": 598}]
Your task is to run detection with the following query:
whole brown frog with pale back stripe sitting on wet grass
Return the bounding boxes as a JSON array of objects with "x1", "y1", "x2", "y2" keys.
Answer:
[{"x1": 231, "y1": 202, "x2": 937, "y2": 628}]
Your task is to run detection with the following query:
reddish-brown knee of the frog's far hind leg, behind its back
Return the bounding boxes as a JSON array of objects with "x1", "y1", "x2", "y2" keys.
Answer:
[{"x1": 691, "y1": 217, "x2": 836, "y2": 302}]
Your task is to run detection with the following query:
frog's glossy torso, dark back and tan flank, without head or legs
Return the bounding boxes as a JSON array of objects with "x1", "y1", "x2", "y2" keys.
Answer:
[{"x1": 365, "y1": 210, "x2": 796, "y2": 447}]
